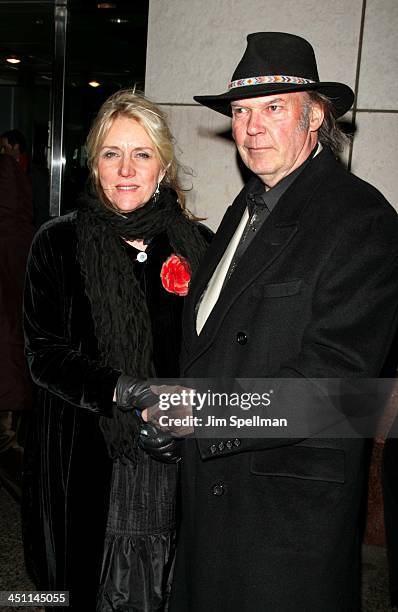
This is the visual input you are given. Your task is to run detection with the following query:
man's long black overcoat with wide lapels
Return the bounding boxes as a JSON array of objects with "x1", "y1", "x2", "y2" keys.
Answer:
[{"x1": 171, "y1": 149, "x2": 398, "y2": 612}]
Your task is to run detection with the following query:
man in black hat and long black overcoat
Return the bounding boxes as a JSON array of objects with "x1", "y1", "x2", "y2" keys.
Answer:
[{"x1": 171, "y1": 32, "x2": 398, "y2": 612}]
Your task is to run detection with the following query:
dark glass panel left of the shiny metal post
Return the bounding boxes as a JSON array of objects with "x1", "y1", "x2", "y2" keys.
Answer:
[{"x1": 0, "y1": 0, "x2": 54, "y2": 227}]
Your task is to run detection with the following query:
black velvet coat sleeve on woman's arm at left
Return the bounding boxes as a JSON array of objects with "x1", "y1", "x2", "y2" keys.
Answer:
[{"x1": 24, "y1": 218, "x2": 121, "y2": 416}]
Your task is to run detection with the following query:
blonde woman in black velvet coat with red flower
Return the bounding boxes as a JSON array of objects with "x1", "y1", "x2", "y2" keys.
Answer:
[{"x1": 25, "y1": 90, "x2": 210, "y2": 612}]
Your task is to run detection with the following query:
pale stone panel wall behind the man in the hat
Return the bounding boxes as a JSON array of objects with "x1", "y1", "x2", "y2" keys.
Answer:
[{"x1": 146, "y1": 0, "x2": 398, "y2": 228}]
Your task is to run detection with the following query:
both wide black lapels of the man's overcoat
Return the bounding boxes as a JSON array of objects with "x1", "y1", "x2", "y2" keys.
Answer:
[{"x1": 184, "y1": 149, "x2": 336, "y2": 368}]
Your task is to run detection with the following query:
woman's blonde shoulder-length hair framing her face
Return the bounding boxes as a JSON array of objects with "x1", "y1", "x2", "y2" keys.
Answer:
[{"x1": 86, "y1": 89, "x2": 185, "y2": 210}]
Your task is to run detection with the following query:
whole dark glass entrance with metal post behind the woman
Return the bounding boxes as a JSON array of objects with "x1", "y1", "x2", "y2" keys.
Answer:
[{"x1": 0, "y1": 0, "x2": 149, "y2": 220}]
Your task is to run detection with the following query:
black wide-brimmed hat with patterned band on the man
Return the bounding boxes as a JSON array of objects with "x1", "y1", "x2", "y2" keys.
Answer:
[{"x1": 194, "y1": 32, "x2": 354, "y2": 117}]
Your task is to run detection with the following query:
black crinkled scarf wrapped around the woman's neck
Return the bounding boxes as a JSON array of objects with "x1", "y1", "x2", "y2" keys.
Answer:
[{"x1": 77, "y1": 188, "x2": 207, "y2": 378}]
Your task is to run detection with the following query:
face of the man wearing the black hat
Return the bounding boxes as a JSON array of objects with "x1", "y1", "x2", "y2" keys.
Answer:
[{"x1": 231, "y1": 92, "x2": 323, "y2": 187}]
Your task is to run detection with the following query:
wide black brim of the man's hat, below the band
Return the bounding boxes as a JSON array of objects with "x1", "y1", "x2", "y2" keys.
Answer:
[{"x1": 193, "y1": 83, "x2": 355, "y2": 117}]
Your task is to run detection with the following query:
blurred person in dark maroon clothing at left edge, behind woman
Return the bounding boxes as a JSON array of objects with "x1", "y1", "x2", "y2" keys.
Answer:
[{"x1": 0, "y1": 154, "x2": 34, "y2": 496}]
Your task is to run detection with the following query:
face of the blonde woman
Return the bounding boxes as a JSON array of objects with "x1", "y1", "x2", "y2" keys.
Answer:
[{"x1": 98, "y1": 116, "x2": 164, "y2": 212}]
